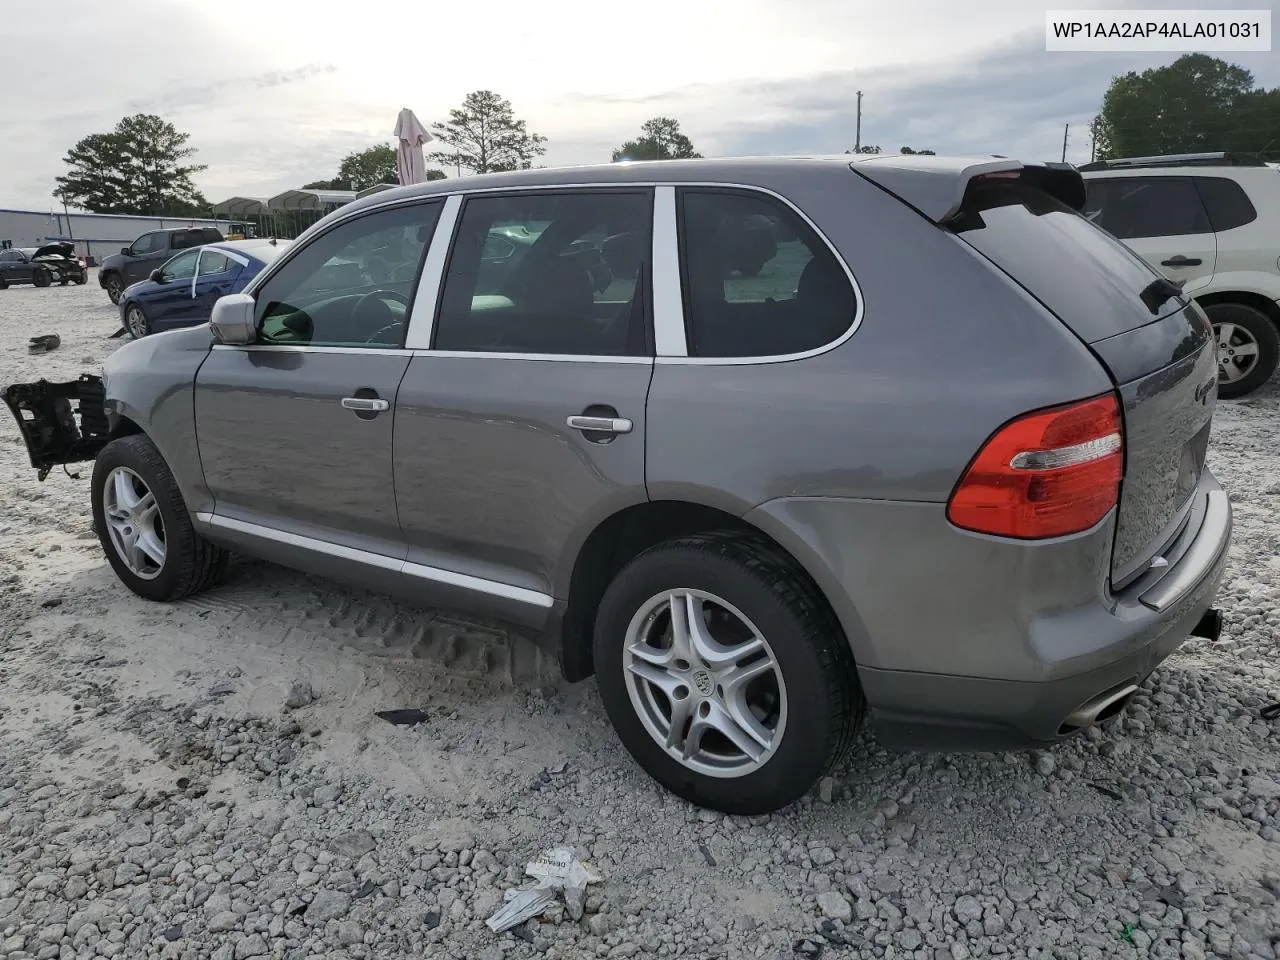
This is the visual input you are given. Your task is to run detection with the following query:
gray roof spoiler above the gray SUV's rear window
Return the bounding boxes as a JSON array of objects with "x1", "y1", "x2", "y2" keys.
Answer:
[{"x1": 850, "y1": 154, "x2": 1084, "y2": 224}]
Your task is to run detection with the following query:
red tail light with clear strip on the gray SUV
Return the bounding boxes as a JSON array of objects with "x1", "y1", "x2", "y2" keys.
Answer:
[{"x1": 947, "y1": 393, "x2": 1124, "y2": 540}]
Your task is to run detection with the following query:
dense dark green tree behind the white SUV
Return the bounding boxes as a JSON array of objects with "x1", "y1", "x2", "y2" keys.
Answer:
[{"x1": 1094, "y1": 54, "x2": 1280, "y2": 160}]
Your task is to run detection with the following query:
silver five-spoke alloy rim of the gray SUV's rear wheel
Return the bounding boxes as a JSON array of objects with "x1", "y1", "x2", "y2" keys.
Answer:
[{"x1": 622, "y1": 590, "x2": 787, "y2": 777}]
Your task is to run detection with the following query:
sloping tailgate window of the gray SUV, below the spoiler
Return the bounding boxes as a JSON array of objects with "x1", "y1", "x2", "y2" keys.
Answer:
[{"x1": 950, "y1": 182, "x2": 1183, "y2": 343}]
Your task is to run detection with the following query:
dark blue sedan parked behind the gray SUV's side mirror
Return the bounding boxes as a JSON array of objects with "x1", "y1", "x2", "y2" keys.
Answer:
[{"x1": 120, "y1": 239, "x2": 292, "y2": 339}]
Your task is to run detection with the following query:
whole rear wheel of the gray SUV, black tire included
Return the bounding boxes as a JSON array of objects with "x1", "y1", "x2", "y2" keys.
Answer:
[{"x1": 594, "y1": 532, "x2": 865, "y2": 814}]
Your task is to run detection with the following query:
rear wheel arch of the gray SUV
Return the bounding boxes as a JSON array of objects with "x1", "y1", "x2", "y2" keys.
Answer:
[{"x1": 558, "y1": 499, "x2": 865, "y2": 681}]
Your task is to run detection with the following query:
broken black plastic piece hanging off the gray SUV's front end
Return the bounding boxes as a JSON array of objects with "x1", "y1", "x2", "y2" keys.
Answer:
[{"x1": 3, "y1": 374, "x2": 110, "y2": 480}]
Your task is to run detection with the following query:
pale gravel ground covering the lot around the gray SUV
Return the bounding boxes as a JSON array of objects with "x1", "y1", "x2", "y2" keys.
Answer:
[{"x1": 0, "y1": 278, "x2": 1280, "y2": 960}]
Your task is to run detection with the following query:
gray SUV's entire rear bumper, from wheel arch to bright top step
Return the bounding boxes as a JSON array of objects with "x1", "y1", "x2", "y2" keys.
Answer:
[{"x1": 748, "y1": 470, "x2": 1231, "y2": 750}]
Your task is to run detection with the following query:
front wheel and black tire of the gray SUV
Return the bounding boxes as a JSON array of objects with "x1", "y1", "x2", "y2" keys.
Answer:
[{"x1": 91, "y1": 434, "x2": 227, "y2": 603}]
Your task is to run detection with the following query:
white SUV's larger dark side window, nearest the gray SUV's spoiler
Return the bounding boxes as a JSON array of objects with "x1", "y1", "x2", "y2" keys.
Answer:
[{"x1": 1084, "y1": 177, "x2": 1213, "y2": 239}]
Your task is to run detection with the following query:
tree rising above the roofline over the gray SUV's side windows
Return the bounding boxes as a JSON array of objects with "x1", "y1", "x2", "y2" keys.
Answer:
[{"x1": 428, "y1": 90, "x2": 547, "y2": 173}]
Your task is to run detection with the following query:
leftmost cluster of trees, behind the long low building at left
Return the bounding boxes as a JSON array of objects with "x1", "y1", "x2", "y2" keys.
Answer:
[{"x1": 54, "y1": 114, "x2": 209, "y2": 216}]
